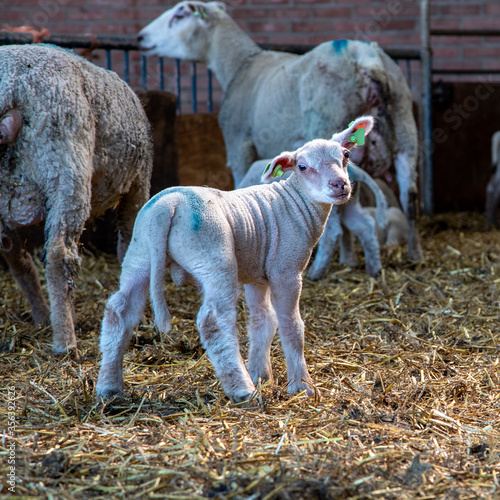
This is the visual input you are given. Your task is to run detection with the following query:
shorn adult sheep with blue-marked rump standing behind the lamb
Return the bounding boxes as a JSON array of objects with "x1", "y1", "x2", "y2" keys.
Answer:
[{"x1": 138, "y1": 1, "x2": 423, "y2": 260}]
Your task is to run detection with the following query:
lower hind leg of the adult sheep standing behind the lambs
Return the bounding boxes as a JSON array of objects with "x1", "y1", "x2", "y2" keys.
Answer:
[{"x1": 394, "y1": 153, "x2": 424, "y2": 260}]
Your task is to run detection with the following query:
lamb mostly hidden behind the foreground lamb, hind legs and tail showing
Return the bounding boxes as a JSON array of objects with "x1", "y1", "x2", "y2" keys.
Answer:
[{"x1": 237, "y1": 160, "x2": 387, "y2": 281}]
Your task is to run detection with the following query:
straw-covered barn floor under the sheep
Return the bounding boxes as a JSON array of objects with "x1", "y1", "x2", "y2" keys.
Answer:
[{"x1": 0, "y1": 213, "x2": 500, "y2": 500}]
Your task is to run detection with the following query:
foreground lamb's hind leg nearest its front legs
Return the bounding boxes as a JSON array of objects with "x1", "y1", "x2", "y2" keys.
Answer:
[{"x1": 197, "y1": 282, "x2": 255, "y2": 402}]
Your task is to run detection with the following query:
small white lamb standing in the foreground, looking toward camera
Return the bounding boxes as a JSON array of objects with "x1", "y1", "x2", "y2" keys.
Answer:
[{"x1": 96, "y1": 116, "x2": 373, "y2": 401}]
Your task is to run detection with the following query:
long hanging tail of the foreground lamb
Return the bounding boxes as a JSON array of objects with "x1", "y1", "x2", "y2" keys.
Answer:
[{"x1": 149, "y1": 201, "x2": 174, "y2": 333}]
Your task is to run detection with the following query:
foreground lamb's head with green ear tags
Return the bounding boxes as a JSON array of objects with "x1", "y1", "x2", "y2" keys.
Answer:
[{"x1": 261, "y1": 116, "x2": 373, "y2": 205}]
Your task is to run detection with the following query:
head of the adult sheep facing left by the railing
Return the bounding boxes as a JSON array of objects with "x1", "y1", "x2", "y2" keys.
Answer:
[{"x1": 137, "y1": 1, "x2": 226, "y2": 63}]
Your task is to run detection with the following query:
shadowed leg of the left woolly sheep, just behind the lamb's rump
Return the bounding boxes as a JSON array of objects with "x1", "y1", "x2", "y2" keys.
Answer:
[{"x1": 116, "y1": 176, "x2": 150, "y2": 263}]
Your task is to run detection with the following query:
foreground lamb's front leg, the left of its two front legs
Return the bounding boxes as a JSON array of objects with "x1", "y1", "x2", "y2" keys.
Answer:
[{"x1": 245, "y1": 285, "x2": 278, "y2": 384}]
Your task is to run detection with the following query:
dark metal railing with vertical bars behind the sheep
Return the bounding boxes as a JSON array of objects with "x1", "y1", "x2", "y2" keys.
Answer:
[{"x1": 0, "y1": 31, "x2": 420, "y2": 113}]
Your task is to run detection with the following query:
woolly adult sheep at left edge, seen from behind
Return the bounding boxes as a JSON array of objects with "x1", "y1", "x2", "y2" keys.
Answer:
[{"x1": 0, "y1": 45, "x2": 153, "y2": 354}]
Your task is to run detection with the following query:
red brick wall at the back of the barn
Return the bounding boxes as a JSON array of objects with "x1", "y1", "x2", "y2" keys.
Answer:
[{"x1": 0, "y1": 0, "x2": 500, "y2": 106}]
